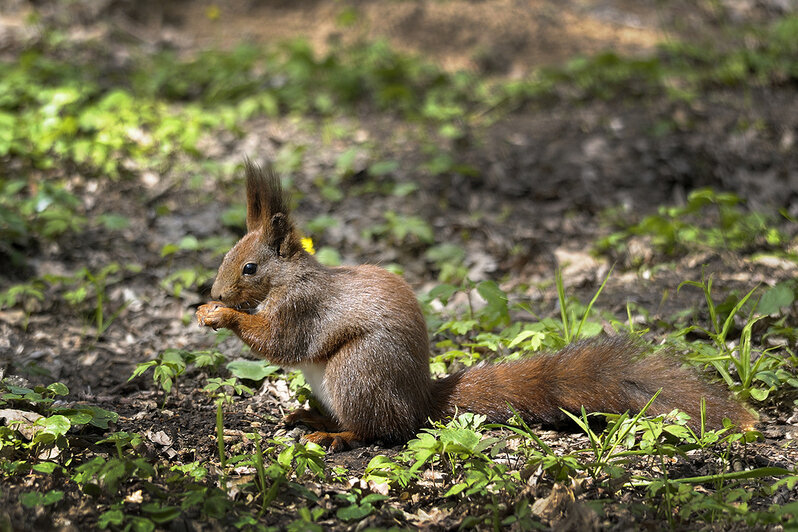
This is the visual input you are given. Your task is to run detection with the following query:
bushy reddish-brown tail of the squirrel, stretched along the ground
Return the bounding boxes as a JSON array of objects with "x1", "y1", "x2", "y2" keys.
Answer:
[{"x1": 434, "y1": 337, "x2": 755, "y2": 428}]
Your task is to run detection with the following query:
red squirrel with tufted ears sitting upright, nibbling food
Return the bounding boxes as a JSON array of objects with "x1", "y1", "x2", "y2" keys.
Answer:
[{"x1": 197, "y1": 161, "x2": 754, "y2": 450}]
